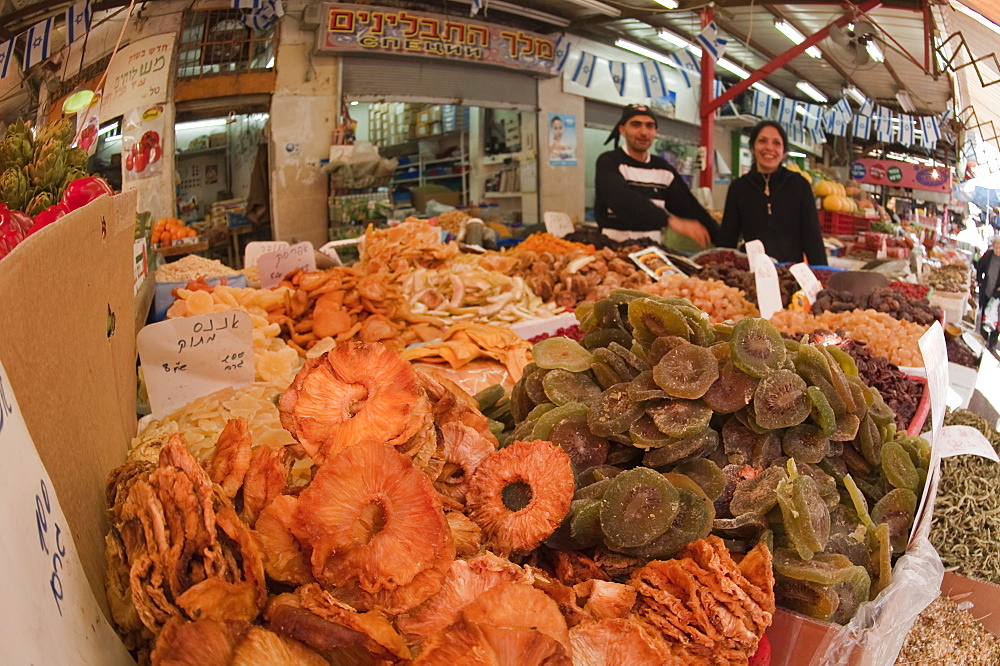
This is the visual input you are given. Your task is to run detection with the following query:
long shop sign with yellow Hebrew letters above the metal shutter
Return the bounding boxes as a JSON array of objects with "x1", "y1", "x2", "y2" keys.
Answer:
[{"x1": 317, "y1": 4, "x2": 558, "y2": 75}]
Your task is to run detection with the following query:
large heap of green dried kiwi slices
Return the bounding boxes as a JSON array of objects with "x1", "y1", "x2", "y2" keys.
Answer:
[{"x1": 510, "y1": 290, "x2": 930, "y2": 623}]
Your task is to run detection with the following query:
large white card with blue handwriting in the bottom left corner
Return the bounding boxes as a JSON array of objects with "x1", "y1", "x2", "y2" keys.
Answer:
[{"x1": 0, "y1": 364, "x2": 135, "y2": 666}]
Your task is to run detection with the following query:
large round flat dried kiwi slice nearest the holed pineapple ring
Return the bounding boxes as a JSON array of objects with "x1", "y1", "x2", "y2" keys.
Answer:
[{"x1": 600, "y1": 467, "x2": 680, "y2": 548}]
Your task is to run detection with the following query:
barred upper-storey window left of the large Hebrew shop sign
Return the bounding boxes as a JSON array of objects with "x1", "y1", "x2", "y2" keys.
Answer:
[{"x1": 177, "y1": 9, "x2": 277, "y2": 78}]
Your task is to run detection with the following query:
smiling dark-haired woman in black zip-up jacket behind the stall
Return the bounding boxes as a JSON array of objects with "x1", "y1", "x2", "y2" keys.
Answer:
[{"x1": 719, "y1": 120, "x2": 826, "y2": 266}]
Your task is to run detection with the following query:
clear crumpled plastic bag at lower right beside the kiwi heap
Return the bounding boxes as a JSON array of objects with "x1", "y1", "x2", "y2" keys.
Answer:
[{"x1": 812, "y1": 537, "x2": 944, "y2": 666}]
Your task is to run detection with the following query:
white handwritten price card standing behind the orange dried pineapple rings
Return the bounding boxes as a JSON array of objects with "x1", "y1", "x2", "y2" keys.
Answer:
[{"x1": 136, "y1": 310, "x2": 254, "y2": 417}]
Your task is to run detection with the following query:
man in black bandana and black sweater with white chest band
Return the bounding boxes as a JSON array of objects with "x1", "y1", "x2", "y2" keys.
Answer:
[{"x1": 594, "y1": 104, "x2": 719, "y2": 247}]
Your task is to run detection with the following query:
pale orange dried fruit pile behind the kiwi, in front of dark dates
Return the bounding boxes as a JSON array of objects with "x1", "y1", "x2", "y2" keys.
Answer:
[{"x1": 771, "y1": 310, "x2": 927, "y2": 368}]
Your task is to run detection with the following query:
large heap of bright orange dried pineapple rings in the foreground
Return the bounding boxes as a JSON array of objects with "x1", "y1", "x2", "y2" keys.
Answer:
[{"x1": 106, "y1": 342, "x2": 774, "y2": 666}]
